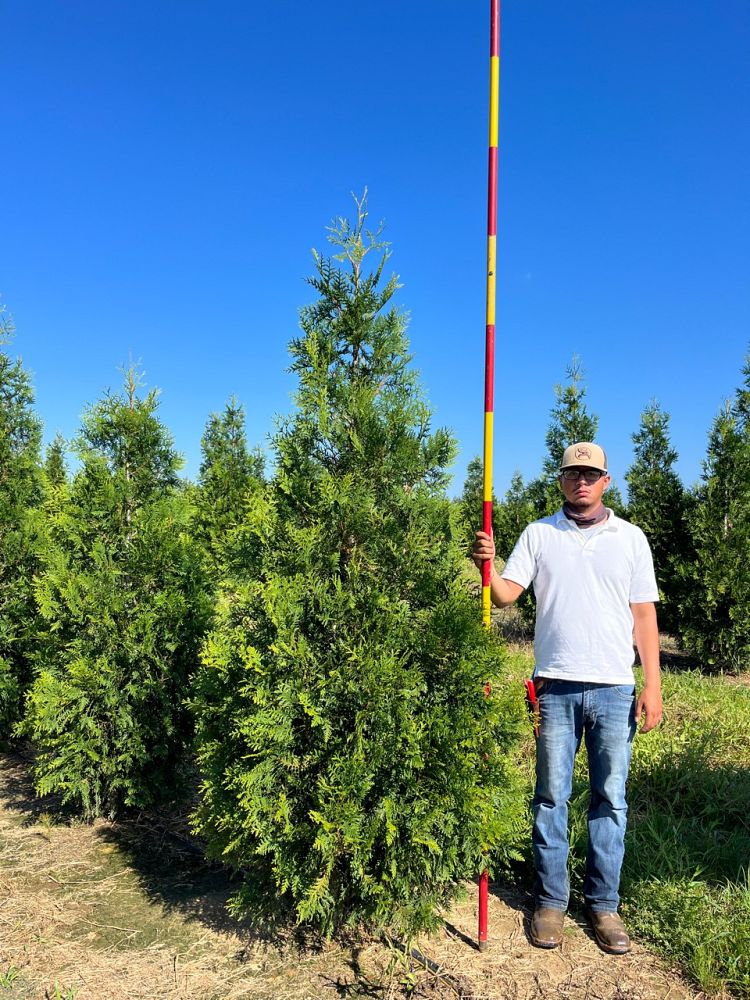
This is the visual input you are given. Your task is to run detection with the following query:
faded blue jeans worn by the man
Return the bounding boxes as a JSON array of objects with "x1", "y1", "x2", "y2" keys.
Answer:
[{"x1": 532, "y1": 680, "x2": 636, "y2": 912}]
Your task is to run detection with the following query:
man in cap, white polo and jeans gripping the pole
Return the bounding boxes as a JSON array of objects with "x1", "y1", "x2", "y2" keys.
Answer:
[{"x1": 473, "y1": 441, "x2": 662, "y2": 955}]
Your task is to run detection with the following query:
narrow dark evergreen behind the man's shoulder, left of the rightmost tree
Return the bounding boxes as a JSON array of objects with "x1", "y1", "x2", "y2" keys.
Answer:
[{"x1": 625, "y1": 400, "x2": 690, "y2": 634}]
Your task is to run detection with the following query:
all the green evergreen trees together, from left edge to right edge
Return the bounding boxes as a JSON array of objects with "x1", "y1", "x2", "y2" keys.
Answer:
[{"x1": 0, "y1": 197, "x2": 750, "y2": 934}]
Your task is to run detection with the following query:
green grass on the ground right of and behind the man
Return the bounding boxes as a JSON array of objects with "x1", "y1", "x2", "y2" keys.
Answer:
[{"x1": 500, "y1": 652, "x2": 750, "y2": 997}]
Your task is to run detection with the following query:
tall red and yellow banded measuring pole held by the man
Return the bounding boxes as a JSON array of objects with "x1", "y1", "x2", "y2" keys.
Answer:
[{"x1": 479, "y1": 0, "x2": 500, "y2": 951}]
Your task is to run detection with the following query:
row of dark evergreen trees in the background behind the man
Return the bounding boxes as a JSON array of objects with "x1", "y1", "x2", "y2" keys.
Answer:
[{"x1": 460, "y1": 356, "x2": 750, "y2": 671}]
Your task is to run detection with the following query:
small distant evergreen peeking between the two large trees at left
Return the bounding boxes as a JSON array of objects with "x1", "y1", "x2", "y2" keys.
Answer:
[{"x1": 194, "y1": 396, "x2": 264, "y2": 579}]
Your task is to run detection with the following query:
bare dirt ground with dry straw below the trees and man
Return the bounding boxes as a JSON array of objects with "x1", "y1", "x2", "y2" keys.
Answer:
[{"x1": 0, "y1": 756, "x2": 716, "y2": 1000}]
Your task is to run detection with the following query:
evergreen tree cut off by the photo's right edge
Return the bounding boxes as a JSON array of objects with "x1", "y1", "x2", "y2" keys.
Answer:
[{"x1": 681, "y1": 355, "x2": 750, "y2": 670}]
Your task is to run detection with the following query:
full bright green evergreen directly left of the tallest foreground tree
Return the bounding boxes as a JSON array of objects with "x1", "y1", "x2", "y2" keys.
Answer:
[{"x1": 25, "y1": 370, "x2": 212, "y2": 815}]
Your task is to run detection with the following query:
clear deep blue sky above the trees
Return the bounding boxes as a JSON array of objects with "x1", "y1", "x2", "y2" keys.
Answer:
[{"x1": 0, "y1": 0, "x2": 750, "y2": 493}]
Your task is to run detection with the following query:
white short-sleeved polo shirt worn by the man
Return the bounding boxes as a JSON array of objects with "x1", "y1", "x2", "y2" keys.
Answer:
[{"x1": 500, "y1": 510, "x2": 659, "y2": 684}]
